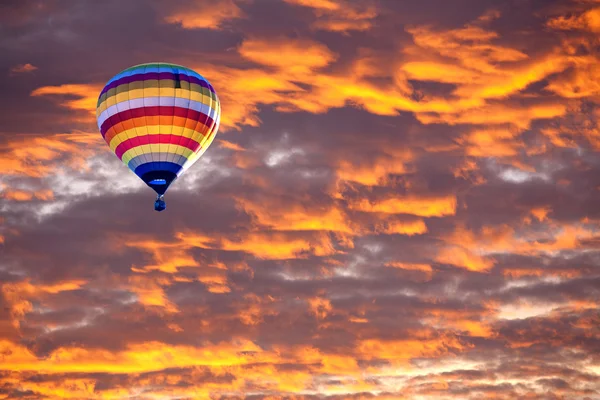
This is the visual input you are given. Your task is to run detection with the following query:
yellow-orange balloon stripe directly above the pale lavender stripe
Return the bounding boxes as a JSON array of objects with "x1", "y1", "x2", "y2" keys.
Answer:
[{"x1": 96, "y1": 81, "x2": 219, "y2": 111}]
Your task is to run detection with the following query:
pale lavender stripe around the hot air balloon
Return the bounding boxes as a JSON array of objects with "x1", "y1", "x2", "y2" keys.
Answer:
[{"x1": 98, "y1": 96, "x2": 216, "y2": 127}]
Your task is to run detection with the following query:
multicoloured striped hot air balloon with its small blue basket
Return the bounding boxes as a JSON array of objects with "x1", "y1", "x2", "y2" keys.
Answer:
[{"x1": 96, "y1": 63, "x2": 221, "y2": 211}]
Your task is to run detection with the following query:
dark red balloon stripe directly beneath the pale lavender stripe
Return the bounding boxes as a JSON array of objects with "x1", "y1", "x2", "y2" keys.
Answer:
[{"x1": 99, "y1": 106, "x2": 215, "y2": 137}]
